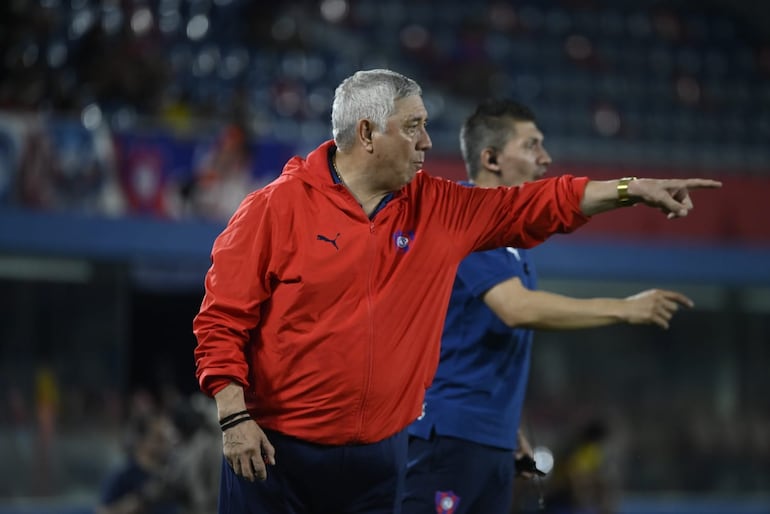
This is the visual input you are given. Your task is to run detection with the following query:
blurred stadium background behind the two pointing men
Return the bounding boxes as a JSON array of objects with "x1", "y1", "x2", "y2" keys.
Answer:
[{"x1": 0, "y1": 0, "x2": 770, "y2": 514}]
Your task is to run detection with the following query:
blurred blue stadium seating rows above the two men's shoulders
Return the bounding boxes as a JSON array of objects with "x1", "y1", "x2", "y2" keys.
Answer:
[{"x1": 0, "y1": 0, "x2": 770, "y2": 168}]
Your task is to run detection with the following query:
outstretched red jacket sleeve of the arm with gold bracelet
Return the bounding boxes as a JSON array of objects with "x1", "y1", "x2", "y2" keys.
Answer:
[{"x1": 426, "y1": 175, "x2": 590, "y2": 252}]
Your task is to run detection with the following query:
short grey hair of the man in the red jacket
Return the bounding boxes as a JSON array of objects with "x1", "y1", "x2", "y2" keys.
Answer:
[{"x1": 332, "y1": 70, "x2": 422, "y2": 150}]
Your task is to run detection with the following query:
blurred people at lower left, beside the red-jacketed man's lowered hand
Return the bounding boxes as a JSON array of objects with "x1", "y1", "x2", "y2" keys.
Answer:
[{"x1": 0, "y1": 367, "x2": 222, "y2": 514}]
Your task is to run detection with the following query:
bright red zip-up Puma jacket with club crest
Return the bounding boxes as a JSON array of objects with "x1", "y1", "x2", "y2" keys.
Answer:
[{"x1": 193, "y1": 141, "x2": 588, "y2": 445}]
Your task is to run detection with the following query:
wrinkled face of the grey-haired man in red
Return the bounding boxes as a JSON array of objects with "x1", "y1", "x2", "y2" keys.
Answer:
[{"x1": 372, "y1": 96, "x2": 431, "y2": 191}]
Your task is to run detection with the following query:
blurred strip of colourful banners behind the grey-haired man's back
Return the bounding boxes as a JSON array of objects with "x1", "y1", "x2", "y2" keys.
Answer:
[{"x1": 0, "y1": 113, "x2": 294, "y2": 221}]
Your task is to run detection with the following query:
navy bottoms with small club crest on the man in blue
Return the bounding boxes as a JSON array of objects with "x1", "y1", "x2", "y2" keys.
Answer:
[{"x1": 401, "y1": 435, "x2": 515, "y2": 514}]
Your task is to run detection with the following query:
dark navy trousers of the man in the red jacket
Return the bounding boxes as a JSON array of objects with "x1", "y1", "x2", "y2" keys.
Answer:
[{"x1": 219, "y1": 430, "x2": 407, "y2": 514}]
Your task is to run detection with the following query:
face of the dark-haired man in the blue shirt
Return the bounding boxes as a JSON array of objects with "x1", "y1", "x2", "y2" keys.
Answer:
[{"x1": 497, "y1": 121, "x2": 551, "y2": 186}]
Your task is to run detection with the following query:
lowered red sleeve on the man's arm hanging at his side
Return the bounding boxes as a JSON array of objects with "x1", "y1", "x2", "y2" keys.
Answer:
[{"x1": 193, "y1": 193, "x2": 273, "y2": 396}]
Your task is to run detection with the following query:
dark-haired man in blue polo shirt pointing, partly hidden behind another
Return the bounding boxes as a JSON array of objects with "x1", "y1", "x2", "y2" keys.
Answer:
[{"x1": 403, "y1": 100, "x2": 692, "y2": 514}]
